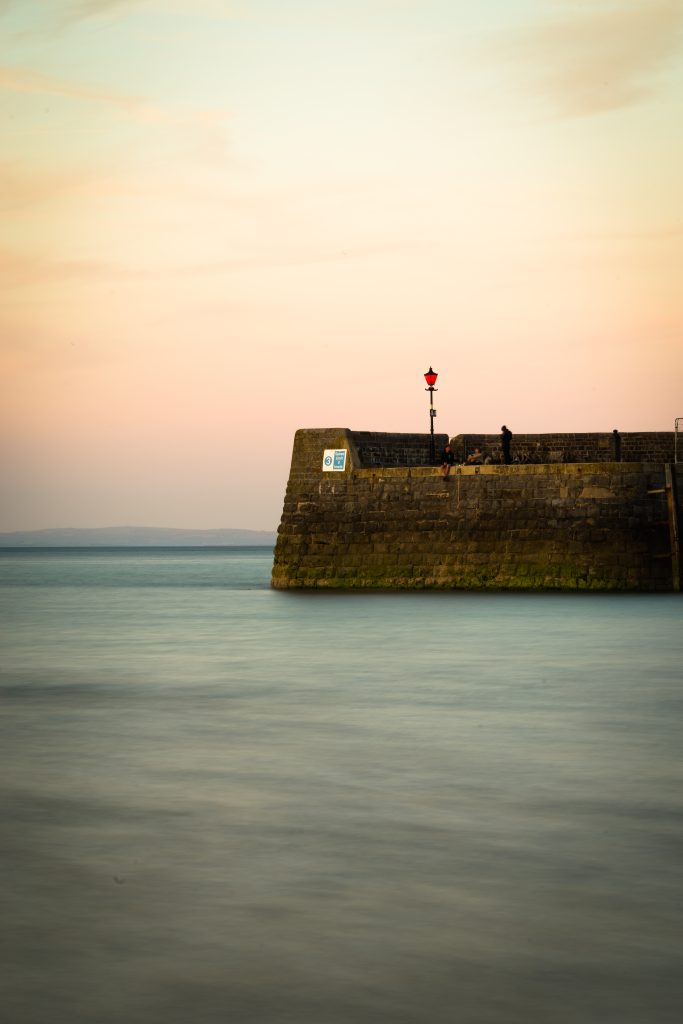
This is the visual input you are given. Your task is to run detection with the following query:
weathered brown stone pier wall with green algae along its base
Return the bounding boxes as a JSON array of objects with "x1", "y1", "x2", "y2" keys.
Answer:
[{"x1": 272, "y1": 428, "x2": 683, "y2": 591}]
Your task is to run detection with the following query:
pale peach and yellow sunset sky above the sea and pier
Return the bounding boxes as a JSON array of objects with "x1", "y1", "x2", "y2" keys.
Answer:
[{"x1": 0, "y1": 0, "x2": 683, "y2": 530}]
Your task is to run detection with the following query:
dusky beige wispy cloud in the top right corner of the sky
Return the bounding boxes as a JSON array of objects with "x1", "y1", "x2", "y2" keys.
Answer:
[{"x1": 496, "y1": 0, "x2": 683, "y2": 117}]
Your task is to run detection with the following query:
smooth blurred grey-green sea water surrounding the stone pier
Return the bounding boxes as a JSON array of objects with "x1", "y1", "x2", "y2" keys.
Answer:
[{"x1": 0, "y1": 549, "x2": 683, "y2": 1024}]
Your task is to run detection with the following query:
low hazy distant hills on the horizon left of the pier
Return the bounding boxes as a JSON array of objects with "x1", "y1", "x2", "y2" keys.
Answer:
[{"x1": 0, "y1": 526, "x2": 276, "y2": 548}]
